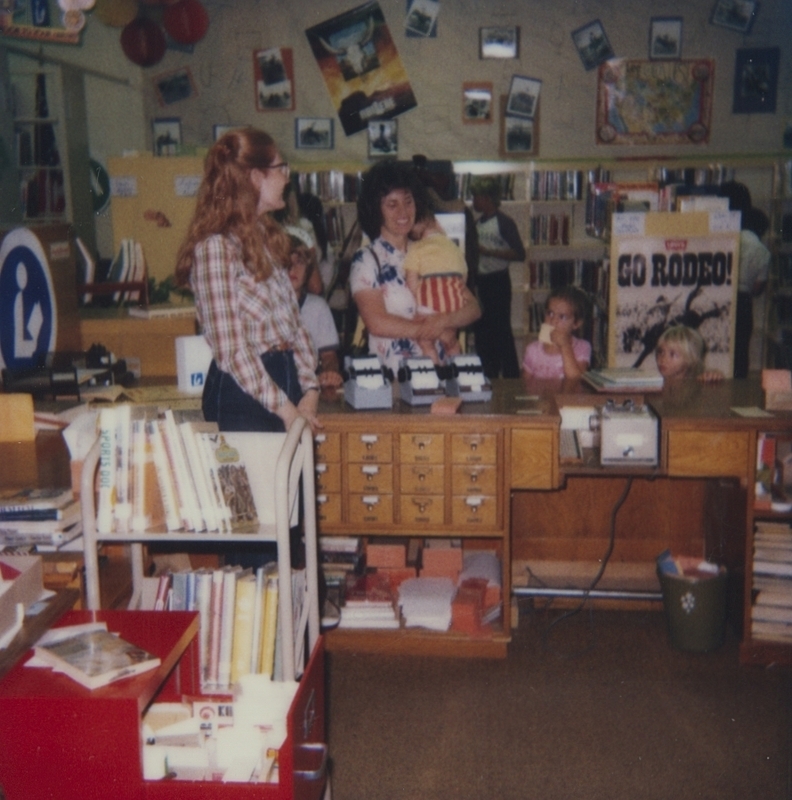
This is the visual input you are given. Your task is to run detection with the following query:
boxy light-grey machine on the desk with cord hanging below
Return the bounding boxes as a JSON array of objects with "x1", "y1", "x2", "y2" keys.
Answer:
[{"x1": 600, "y1": 400, "x2": 658, "y2": 467}]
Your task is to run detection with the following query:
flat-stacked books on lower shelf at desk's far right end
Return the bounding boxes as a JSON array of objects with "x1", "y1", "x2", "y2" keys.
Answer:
[{"x1": 751, "y1": 520, "x2": 792, "y2": 643}]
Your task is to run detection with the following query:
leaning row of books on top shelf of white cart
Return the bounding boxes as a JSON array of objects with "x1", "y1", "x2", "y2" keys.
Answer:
[{"x1": 96, "y1": 404, "x2": 259, "y2": 534}]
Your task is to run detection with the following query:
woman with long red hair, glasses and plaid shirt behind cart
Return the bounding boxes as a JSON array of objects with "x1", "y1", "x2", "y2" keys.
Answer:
[{"x1": 176, "y1": 128, "x2": 319, "y2": 431}]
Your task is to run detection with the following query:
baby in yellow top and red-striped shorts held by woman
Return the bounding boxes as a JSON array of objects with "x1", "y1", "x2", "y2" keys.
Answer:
[{"x1": 404, "y1": 210, "x2": 467, "y2": 364}]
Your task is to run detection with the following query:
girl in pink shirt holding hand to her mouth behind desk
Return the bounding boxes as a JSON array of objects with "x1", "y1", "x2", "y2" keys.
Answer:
[{"x1": 523, "y1": 286, "x2": 591, "y2": 378}]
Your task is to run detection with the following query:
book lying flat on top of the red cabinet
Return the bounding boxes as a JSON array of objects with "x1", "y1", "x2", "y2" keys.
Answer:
[{"x1": 35, "y1": 623, "x2": 161, "y2": 689}]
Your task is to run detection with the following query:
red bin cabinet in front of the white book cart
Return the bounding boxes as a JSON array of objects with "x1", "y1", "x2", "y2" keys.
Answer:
[{"x1": 0, "y1": 611, "x2": 326, "y2": 800}]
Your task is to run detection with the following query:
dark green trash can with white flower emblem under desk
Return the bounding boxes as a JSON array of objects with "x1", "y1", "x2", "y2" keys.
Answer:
[{"x1": 657, "y1": 567, "x2": 727, "y2": 653}]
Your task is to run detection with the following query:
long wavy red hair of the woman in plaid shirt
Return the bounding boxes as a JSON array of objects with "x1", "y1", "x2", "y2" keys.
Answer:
[{"x1": 176, "y1": 128, "x2": 289, "y2": 286}]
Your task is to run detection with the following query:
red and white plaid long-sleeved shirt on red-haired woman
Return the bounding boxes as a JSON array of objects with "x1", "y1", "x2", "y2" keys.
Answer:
[{"x1": 190, "y1": 235, "x2": 319, "y2": 411}]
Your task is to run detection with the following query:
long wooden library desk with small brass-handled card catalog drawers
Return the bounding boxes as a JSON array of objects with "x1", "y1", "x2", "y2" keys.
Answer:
[{"x1": 316, "y1": 380, "x2": 792, "y2": 663}]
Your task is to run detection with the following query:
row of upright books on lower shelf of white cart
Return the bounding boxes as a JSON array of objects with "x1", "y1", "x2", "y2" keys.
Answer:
[{"x1": 141, "y1": 562, "x2": 308, "y2": 692}]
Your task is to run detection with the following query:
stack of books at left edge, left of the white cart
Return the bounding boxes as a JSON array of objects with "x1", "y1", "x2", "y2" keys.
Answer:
[{"x1": 0, "y1": 487, "x2": 82, "y2": 551}]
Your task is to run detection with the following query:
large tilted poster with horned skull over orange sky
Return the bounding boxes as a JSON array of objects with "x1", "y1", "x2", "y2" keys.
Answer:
[{"x1": 305, "y1": 2, "x2": 417, "y2": 136}]
